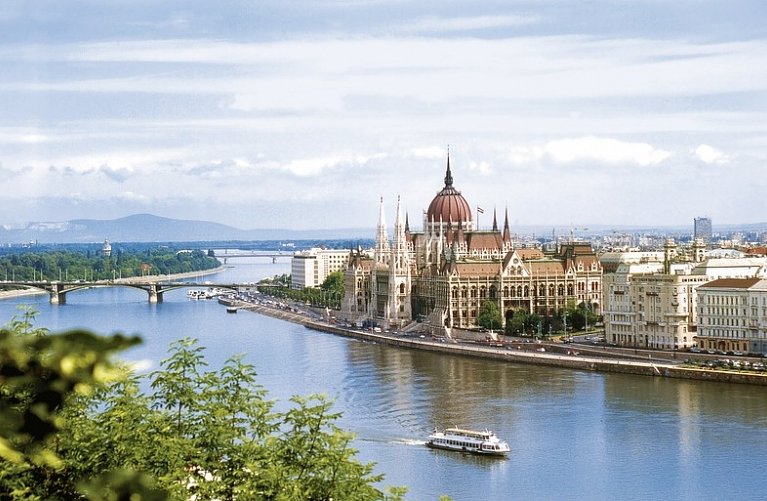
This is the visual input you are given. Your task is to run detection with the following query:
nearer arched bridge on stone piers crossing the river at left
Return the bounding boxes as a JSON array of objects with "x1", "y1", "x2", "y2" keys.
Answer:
[{"x1": 0, "y1": 279, "x2": 253, "y2": 304}]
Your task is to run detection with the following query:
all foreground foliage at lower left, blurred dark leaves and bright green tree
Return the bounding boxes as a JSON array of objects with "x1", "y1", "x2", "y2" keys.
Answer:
[{"x1": 0, "y1": 316, "x2": 406, "y2": 501}]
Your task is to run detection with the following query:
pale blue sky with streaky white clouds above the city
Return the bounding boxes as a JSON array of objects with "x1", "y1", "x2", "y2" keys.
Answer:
[{"x1": 0, "y1": 0, "x2": 767, "y2": 229}]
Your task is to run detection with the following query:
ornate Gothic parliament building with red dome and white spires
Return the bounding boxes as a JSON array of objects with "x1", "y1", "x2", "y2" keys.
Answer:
[{"x1": 340, "y1": 155, "x2": 602, "y2": 334}]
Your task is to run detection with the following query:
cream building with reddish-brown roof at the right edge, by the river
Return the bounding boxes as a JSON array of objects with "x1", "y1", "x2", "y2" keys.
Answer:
[{"x1": 697, "y1": 278, "x2": 767, "y2": 355}]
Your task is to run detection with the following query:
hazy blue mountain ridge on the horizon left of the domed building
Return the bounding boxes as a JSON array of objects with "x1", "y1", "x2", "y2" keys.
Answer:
[{"x1": 0, "y1": 214, "x2": 374, "y2": 243}]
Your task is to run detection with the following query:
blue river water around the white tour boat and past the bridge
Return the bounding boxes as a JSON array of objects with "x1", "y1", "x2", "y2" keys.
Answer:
[{"x1": 0, "y1": 258, "x2": 767, "y2": 501}]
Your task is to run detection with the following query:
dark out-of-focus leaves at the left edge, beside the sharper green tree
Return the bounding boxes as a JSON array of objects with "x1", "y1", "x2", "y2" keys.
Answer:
[{"x1": 0, "y1": 310, "x2": 139, "y2": 499}]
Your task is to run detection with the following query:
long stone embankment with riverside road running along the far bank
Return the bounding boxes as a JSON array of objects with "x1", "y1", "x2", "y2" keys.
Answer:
[{"x1": 220, "y1": 299, "x2": 767, "y2": 386}]
